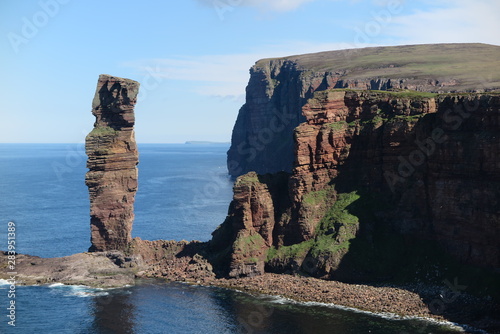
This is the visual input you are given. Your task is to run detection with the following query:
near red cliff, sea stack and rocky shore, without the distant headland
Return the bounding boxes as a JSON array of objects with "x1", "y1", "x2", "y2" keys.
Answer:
[{"x1": 0, "y1": 69, "x2": 500, "y2": 333}]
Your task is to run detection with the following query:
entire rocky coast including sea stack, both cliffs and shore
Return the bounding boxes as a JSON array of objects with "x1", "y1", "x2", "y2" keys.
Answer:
[{"x1": 0, "y1": 44, "x2": 500, "y2": 332}]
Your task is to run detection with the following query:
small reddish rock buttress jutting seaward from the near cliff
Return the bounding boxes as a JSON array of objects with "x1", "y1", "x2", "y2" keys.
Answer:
[{"x1": 210, "y1": 172, "x2": 288, "y2": 277}]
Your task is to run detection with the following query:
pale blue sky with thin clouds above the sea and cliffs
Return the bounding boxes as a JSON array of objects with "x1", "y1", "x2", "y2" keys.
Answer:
[{"x1": 0, "y1": 0, "x2": 500, "y2": 143}]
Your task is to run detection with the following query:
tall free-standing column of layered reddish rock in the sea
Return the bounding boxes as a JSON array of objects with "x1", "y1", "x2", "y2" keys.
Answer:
[{"x1": 85, "y1": 74, "x2": 139, "y2": 251}]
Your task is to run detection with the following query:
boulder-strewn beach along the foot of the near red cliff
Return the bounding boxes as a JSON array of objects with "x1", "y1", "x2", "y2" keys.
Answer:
[{"x1": 141, "y1": 260, "x2": 500, "y2": 333}]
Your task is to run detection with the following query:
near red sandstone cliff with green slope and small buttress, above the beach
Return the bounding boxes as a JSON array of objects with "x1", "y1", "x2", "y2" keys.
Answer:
[{"x1": 212, "y1": 90, "x2": 500, "y2": 280}]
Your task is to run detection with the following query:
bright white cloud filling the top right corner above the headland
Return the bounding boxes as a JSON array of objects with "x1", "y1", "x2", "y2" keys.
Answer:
[{"x1": 387, "y1": 0, "x2": 500, "y2": 45}]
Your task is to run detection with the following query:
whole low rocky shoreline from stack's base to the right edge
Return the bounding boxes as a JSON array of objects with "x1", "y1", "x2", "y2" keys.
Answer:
[{"x1": 0, "y1": 247, "x2": 500, "y2": 333}]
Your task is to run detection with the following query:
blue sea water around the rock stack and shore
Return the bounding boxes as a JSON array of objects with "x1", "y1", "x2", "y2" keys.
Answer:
[{"x1": 0, "y1": 143, "x2": 474, "y2": 334}]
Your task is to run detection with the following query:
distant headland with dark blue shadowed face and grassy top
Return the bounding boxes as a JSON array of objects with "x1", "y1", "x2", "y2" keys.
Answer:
[{"x1": 228, "y1": 44, "x2": 500, "y2": 176}]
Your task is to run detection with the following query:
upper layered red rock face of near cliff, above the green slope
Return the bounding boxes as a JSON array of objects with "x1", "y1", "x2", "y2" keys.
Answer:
[{"x1": 290, "y1": 91, "x2": 500, "y2": 269}]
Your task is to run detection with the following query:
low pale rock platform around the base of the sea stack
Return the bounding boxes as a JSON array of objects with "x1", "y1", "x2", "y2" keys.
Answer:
[{"x1": 0, "y1": 238, "x2": 215, "y2": 288}]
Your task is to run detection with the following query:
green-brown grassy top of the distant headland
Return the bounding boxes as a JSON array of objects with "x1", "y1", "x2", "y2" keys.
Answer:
[{"x1": 256, "y1": 43, "x2": 500, "y2": 90}]
